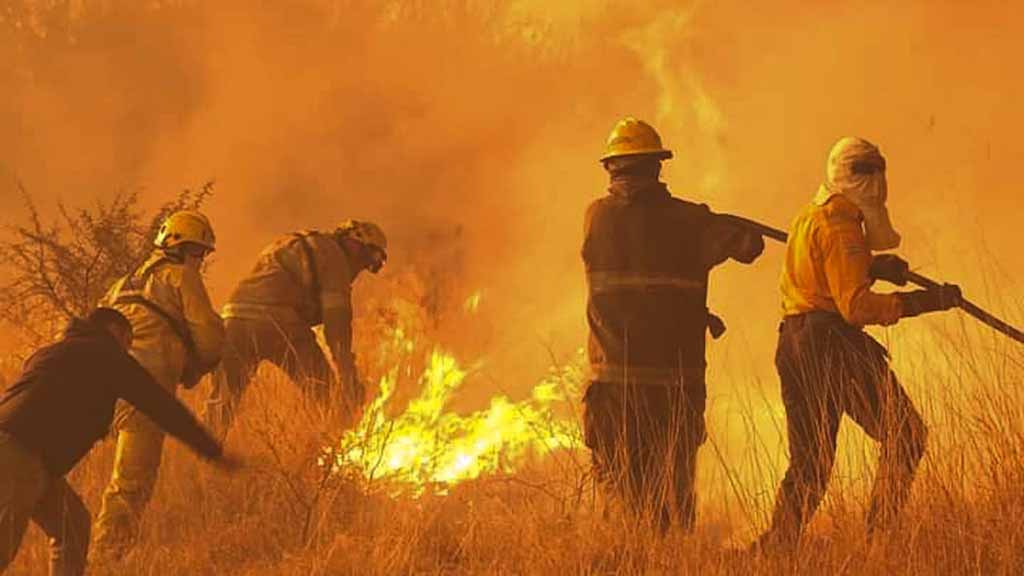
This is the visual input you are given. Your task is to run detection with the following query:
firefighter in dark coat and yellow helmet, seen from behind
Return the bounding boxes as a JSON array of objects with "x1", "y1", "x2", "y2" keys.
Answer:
[{"x1": 583, "y1": 118, "x2": 764, "y2": 530}]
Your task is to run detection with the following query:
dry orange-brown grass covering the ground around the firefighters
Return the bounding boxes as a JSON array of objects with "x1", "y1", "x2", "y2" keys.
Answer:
[{"x1": 10, "y1": 313, "x2": 1024, "y2": 575}]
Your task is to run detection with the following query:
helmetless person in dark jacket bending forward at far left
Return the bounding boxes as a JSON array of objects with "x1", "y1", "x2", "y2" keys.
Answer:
[{"x1": 0, "y1": 307, "x2": 233, "y2": 575}]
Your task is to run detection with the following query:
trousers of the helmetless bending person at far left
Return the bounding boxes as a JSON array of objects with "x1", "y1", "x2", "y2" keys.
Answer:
[{"x1": 0, "y1": 433, "x2": 91, "y2": 576}]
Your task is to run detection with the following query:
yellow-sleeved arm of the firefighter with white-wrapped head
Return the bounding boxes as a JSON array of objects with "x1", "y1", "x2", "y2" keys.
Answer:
[{"x1": 816, "y1": 217, "x2": 903, "y2": 326}]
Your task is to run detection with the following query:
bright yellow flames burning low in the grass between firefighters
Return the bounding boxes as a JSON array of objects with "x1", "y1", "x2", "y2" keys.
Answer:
[{"x1": 319, "y1": 292, "x2": 582, "y2": 496}]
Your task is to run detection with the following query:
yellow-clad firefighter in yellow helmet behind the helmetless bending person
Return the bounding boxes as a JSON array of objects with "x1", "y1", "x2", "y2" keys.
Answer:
[{"x1": 93, "y1": 211, "x2": 224, "y2": 560}]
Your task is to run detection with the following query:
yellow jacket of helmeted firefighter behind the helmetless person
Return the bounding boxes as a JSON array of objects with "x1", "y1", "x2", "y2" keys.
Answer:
[{"x1": 103, "y1": 250, "x2": 224, "y2": 388}]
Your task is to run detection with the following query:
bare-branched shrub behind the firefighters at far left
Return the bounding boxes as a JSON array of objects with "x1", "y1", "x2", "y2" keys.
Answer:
[{"x1": 0, "y1": 181, "x2": 213, "y2": 342}]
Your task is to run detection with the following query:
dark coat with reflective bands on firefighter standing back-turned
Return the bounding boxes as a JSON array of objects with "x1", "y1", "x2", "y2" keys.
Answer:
[{"x1": 583, "y1": 178, "x2": 764, "y2": 401}]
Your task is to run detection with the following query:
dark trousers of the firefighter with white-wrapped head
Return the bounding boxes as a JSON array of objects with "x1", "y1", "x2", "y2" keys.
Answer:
[{"x1": 765, "y1": 313, "x2": 927, "y2": 544}]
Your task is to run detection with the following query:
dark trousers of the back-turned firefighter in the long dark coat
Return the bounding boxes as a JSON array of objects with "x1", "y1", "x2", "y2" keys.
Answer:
[{"x1": 584, "y1": 382, "x2": 705, "y2": 530}]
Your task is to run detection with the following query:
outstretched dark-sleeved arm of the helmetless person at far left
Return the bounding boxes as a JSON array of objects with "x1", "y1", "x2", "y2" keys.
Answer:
[{"x1": 111, "y1": 353, "x2": 222, "y2": 460}]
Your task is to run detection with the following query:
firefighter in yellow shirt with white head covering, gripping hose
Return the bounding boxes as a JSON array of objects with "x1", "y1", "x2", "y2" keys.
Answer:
[{"x1": 755, "y1": 137, "x2": 961, "y2": 550}]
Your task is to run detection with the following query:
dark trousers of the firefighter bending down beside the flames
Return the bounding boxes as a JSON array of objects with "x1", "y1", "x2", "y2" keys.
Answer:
[{"x1": 205, "y1": 318, "x2": 336, "y2": 439}]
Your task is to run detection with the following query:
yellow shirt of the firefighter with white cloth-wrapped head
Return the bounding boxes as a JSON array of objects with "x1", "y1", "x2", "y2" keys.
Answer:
[{"x1": 781, "y1": 191, "x2": 903, "y2": 326}]
